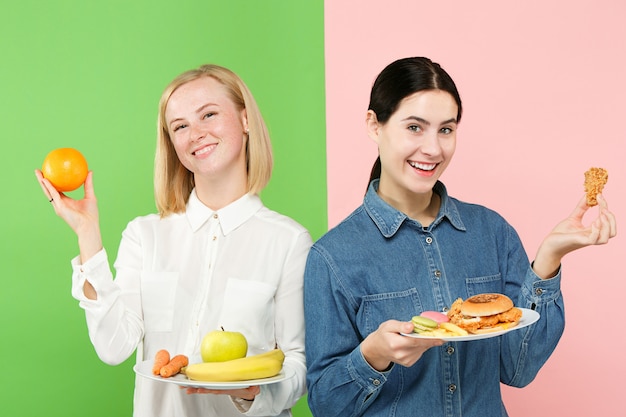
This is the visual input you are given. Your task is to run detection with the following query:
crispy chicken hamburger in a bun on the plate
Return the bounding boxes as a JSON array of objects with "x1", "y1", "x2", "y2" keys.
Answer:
[{"x1": 448, "y1": 293, "x2": 522, "y2": 334}]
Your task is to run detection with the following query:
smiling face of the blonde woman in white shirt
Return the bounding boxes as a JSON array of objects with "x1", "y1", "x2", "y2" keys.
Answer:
[{"x1": 165, "y1": 77, "x2": 247, "y2": 188}]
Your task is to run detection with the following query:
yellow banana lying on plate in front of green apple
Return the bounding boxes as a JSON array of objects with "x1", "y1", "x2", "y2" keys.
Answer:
[{"x1": 185, "y1": 349, "x2": 285, "y2": 382}]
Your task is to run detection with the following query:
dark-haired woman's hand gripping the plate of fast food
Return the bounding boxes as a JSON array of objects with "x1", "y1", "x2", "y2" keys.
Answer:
[{"x1": 361, "y1": 320, "x2": 444, "y2": 372}]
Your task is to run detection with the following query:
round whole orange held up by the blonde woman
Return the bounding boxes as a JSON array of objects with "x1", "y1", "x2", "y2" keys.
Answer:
[{"x1": 41, "y1": 148, "x2": 88, "y2": 192}]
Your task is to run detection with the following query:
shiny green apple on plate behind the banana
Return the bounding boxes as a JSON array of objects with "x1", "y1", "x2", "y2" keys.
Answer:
[{"x1": 200, "y1": 328, "x2": 248, "y2": 362}]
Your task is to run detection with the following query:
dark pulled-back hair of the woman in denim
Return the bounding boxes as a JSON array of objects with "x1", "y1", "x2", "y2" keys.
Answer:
[{"x1": 367, "y1": 57, "x2": 463, "y2": 186}]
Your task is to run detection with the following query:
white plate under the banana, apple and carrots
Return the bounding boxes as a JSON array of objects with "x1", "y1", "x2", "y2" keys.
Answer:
[{"x1": 133, "y1": 360, "x2": 295, "y2": 390}]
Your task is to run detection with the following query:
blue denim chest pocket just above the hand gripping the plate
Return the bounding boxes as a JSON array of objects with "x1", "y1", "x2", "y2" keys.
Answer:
[{"x1": 357, "y1": 288, "x2": 422, "y2": 337}]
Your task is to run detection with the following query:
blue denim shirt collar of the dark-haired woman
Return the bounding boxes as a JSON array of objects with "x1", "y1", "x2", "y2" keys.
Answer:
[{"x1": 363, "y1": 179, "x2": 465, "y2": 237}]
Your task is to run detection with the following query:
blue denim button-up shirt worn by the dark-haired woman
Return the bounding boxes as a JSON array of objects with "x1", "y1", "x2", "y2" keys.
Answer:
[{"x1": 304, "y1": 180, "x2": 565, "y2": 417}]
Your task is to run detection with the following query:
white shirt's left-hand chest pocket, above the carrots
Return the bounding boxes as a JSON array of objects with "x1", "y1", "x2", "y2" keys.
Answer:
[{"x1": 141, "y1": 271, "x2": 178, "y2": 332}]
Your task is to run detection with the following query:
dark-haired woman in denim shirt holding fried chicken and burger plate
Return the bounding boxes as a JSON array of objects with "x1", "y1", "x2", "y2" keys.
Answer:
[{"x1": 304, "y1": 58, "x2": 616, "y2": 417}]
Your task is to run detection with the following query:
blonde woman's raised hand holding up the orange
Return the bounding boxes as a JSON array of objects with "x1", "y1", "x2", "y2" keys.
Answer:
[{"x1": 35, "y1": 169, "x2": 102, "y2": 263}]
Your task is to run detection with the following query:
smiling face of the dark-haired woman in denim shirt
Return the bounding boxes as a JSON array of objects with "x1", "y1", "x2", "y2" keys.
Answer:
[{"x1": 367, "y1": 90, "x2": 458, "y2": 212}]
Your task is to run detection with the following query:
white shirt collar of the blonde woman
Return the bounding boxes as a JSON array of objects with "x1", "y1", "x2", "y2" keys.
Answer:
[{"x1": 186, "y1": 189, "x2": 263, "y2": 235}]
